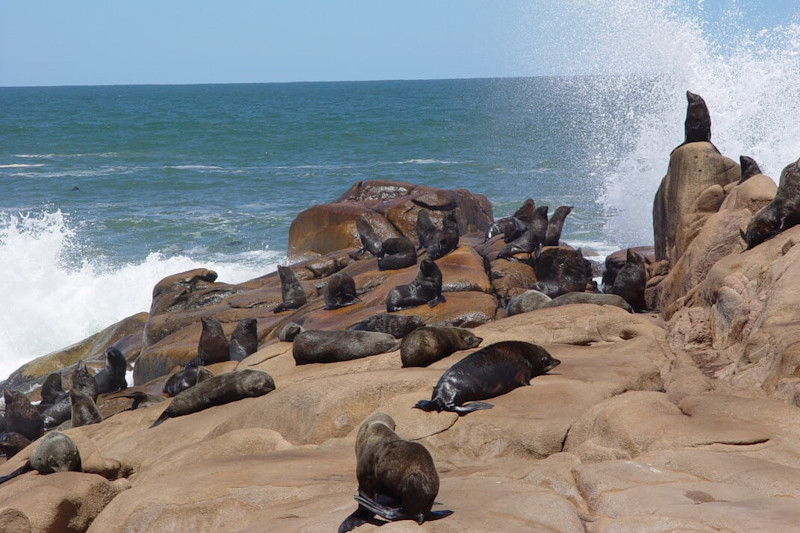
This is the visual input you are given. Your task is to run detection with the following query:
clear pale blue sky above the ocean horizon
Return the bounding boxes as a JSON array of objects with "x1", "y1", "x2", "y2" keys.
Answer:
[{"x1": 0, "y1": 0, "x2": 800, "y2": 86}]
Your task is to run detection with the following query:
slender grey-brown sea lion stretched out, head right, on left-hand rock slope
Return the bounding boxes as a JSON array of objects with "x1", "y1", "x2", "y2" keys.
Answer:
[{"x1": 150, "y1": 369, "x2": 275, "y2": 428}]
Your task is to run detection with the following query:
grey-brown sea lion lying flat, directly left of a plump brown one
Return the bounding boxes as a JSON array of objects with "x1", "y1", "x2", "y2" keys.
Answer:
[{"x1": 292, "y1": 330, "x2": 400, "y2": 365}]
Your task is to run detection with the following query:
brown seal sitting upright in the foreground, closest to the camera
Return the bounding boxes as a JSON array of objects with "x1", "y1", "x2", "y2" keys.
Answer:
[{"x1": 338, "y1": 413, "x2": 453, "y2": 533}]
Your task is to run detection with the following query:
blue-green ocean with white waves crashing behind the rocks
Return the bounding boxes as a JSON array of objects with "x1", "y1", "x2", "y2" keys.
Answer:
[{"x1": 0, "y1": 13, "x2": 800, "y2": 380}]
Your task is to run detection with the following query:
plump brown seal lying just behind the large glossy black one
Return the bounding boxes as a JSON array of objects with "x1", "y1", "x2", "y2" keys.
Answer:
[{"x1": 400, "y1": 326, "x2": 483, "y2": 367}]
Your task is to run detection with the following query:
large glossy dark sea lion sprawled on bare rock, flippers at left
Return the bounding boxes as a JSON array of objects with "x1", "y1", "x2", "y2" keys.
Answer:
[{"x1": 414, "y1": 341, "x2": 561, "y2": 415}]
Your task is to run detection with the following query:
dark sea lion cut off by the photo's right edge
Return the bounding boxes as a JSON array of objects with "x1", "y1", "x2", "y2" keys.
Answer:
[{"x1": 742, "y1": 159, "x2": 800, "y2": 250}]
